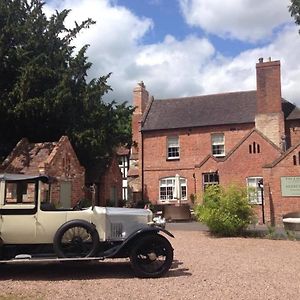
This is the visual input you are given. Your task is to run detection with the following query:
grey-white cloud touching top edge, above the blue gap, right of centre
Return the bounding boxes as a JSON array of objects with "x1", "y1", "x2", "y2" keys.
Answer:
[{"x1": 179, "y1": 0, "x2": 291, "y2": 42}]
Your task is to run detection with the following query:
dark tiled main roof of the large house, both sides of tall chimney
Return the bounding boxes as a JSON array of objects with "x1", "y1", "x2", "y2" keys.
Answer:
[{"x1": 142, "y1": 90, "x2": 300, "y2": 131}]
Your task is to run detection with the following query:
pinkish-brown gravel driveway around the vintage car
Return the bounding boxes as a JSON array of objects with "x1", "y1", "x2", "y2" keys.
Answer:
[{"x1": 0, "y1": 226, "x2": 300, "y2": 300}]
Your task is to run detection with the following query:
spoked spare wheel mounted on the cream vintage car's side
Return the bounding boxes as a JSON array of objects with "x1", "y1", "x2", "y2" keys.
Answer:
[{"x1": 53, "y1": 220, "x2": 99, "y2": 258}]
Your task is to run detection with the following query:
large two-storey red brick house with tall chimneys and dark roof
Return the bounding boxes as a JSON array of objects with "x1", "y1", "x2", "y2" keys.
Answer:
[{"x1": 128, "y1": 59, "x2": 300, "y2": 223}]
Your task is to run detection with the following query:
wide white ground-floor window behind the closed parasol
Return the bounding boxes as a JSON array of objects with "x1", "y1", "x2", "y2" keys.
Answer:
[{"x1": 159, "y1": 177, "x2": 187, "y2": 202}]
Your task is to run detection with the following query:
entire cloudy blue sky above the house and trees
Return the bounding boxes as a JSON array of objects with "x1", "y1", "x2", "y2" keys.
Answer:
[{"x1": 45, "y1": 0, "x2": 300, "y2": 106}]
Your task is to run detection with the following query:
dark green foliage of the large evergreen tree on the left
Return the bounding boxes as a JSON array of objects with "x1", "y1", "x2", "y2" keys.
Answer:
[{"x1": 0, "y1": 0, "x2": 133, "y2": 173}]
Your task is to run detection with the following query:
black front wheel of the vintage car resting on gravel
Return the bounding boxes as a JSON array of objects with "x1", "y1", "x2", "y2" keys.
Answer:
[{"x1": 130, "y1": 234, "x2": 173, "y2": 278}]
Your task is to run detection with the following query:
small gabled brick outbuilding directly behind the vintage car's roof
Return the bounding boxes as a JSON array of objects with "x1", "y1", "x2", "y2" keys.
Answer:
[{"x1": 0, "y1": 136, "x2": 85, "y2": 208}]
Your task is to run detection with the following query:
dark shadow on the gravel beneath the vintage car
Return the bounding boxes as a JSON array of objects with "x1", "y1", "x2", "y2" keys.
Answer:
[{"x1": 0, "y1": 260, "x2": 191, "y2": 281}]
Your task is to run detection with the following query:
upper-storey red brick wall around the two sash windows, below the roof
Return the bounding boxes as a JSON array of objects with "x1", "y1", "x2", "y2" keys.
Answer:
[{"x1": 144, "y1": 124, "x2": 254, "y2": 171}]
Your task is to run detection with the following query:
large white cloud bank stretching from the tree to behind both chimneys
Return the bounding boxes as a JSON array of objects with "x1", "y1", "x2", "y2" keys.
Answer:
[{"x1": 48, "y1": 0, "x2": 300, "y2": 106}]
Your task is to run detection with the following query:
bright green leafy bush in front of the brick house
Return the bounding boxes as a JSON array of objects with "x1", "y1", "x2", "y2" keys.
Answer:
[{"x1": 196, "y1": 185, "x2": 254, "y2": 236}]
